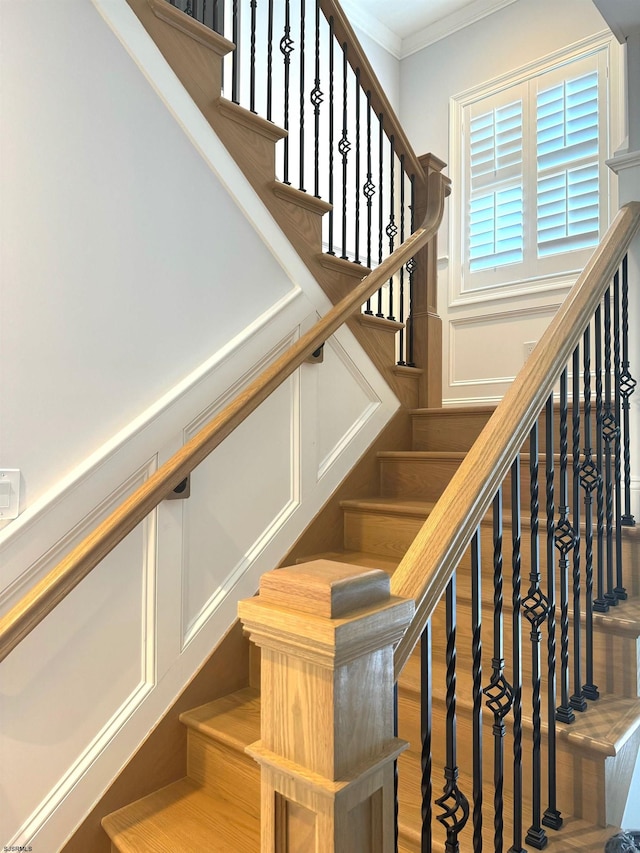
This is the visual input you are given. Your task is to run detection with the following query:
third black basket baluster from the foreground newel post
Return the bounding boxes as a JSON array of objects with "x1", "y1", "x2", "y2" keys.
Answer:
[{"x1": 522, "y1": 422, "x2": 549, "y2": 850}]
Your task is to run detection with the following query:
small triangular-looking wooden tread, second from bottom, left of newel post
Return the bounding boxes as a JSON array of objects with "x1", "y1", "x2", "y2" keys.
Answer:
[{"x1": 180, "y1": 687, "x2": 260, "y2": 750}]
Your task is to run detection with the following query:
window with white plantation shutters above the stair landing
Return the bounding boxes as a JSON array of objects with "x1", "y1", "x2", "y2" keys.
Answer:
[{"x1": 452, "y1": 37, "x2": 611, "y2": 297}]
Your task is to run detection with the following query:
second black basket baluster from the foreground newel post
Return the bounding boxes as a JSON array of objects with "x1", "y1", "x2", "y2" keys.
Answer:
[{"x1": 483, "y1": 488, "x2": 513, "y2": 853}]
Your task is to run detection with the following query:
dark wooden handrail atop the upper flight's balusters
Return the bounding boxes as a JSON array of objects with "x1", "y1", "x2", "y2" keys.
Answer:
[{"x1": 320, "y1": 0, "x2": 427, "y2": 187}]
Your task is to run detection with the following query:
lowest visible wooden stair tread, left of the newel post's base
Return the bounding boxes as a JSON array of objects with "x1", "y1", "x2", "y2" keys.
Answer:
[{"x1": 102, "y1": 778, "x2": 260, "y2": 853}]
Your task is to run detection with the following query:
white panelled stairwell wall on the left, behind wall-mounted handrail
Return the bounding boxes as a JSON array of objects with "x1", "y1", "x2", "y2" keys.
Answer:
[{"x1": 0, "y1": 0, "x2": 397, "y2": 850}]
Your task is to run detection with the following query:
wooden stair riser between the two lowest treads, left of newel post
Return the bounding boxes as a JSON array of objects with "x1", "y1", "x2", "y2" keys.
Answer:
[{"x1": 187, "y1": 730, "x2": 260, "y2": 819}]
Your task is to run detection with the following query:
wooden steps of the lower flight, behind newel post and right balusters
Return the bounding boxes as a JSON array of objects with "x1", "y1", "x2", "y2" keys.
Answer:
[{"x1": 103, "y1": 408, "x2": 640, "y2": 853}]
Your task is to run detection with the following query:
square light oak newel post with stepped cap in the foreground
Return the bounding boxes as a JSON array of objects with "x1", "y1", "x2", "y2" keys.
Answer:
[{"x1": 239, "y1": 560, "x2": 414, "y2": 853}]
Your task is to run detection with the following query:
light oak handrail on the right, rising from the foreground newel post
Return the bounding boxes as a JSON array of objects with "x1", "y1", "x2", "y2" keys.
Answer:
[{"x1": 391, "y1": 202, "x2": 640, "y2": 676}]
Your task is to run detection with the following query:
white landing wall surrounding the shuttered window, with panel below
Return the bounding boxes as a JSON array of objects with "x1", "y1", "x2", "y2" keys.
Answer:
[{"x1": 400, "y1": 0, "x2": 620, "y2": 404}]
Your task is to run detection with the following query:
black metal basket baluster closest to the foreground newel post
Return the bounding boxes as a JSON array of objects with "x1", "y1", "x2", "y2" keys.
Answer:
[{"x1": 436, "y1": 572, "x2": 469, "y2": 853}]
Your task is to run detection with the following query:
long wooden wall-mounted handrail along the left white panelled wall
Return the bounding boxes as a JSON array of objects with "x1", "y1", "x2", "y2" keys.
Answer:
[{"x1": 0, "y1": 168, "x2": 448, "y2": 661}]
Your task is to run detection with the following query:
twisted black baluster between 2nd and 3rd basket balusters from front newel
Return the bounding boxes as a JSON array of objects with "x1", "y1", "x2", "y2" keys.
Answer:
[{"x1": 509, "y1": 455, "x2": 524, "y2": 853}]
